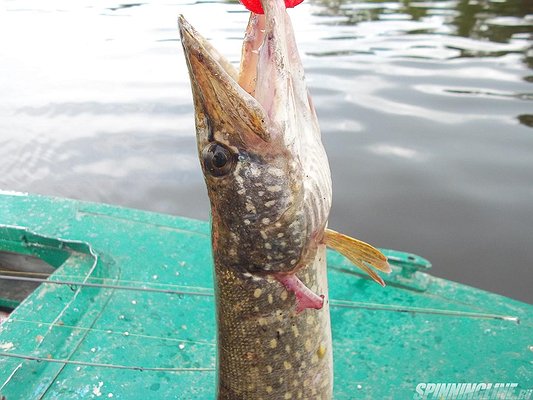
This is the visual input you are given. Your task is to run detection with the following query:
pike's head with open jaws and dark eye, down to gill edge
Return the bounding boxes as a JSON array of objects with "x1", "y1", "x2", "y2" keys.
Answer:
[{"x1": 179, "y1": 0, "x2": 331, "y2": 279}]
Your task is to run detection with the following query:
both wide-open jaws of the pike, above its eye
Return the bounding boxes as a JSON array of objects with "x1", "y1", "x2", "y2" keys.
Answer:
[{"x1": 178, "y1": 0, "x2": 320, "y2": 148}]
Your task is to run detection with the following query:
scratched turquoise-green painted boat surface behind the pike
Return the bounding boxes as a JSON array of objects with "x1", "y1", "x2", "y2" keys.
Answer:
[{"x1": 0, "y1": 193, "x2": 533, "y2": 400}]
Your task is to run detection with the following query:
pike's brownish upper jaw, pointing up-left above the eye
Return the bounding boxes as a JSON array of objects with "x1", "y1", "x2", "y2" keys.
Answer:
[{"x1": 178, "y1": 15, "x2": 270, "y2": 146}]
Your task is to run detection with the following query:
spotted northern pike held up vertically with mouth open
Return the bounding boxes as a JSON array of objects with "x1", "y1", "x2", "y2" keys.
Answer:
[{"x1": 179, "y1": 0, "x2": 390, "y2": 400}]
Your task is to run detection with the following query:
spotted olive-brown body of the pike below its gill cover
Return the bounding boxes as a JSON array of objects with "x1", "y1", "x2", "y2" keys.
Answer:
[{"x1": 215, "y1": 248, "x2": 333, "y2": 400}]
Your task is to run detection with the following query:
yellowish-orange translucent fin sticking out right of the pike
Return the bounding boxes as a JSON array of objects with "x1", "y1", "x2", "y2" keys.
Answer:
[{"x1": 324, "y1": 229, "x2": 391, "y2": 286}]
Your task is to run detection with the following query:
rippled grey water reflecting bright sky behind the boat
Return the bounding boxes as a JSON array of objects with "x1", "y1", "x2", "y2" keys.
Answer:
[{"x1": 0, "y1": 0, "x2": 533, "y2": 302}]
